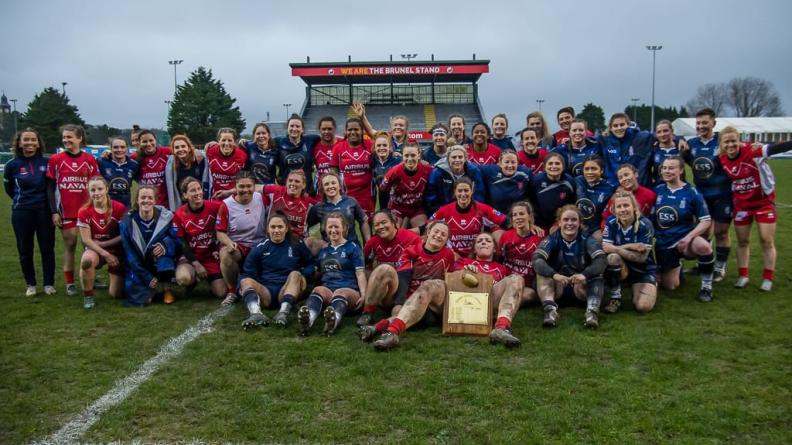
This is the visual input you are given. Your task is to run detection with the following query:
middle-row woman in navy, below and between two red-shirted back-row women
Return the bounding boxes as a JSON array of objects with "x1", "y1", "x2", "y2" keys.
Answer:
[{"x1": 481, "y1": 149, "x2": 532, "y2": 214}]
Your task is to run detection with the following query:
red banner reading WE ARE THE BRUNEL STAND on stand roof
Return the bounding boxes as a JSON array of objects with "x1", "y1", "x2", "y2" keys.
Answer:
[{"x1": 292, "y1": 65, "x2": 489, "y2": 77}]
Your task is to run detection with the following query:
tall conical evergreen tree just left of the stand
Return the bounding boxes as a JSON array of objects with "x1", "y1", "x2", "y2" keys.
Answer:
[{"x1": 168, "y1": 67, "x2": 245, "y2": 144}]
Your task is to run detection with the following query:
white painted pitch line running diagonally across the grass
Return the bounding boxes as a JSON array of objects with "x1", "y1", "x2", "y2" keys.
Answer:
[{"x1": 31, "y1": 306, "x2": 233, "y2": 445}]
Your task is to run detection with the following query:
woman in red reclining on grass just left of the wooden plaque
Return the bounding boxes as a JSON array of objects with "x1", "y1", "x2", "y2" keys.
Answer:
[{"x1": 359, "y1": 221, "x2": 455, "y2": 349}]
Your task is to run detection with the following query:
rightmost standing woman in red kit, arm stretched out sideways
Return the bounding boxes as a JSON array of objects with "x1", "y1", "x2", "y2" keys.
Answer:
[{"x1": 718, "y1": 127, "x2": 792, "y2": 291}]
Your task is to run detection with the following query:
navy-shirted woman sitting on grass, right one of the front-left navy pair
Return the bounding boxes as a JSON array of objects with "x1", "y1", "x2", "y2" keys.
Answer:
[{"x1": 297, "y1": 212, "x2": 366, "y2": 335}]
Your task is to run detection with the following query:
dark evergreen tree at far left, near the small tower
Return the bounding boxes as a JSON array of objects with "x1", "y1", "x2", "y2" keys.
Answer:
[{"x1": 19, "y1": 87, "x2": 85, "y2": 153}]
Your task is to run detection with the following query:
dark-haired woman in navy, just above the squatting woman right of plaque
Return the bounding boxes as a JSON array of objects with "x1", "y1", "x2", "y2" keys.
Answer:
[{"x1": 531, "y1": 152, "x2": 576, "y2": 232}]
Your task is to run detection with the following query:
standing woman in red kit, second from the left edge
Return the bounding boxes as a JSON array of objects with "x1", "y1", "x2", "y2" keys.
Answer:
[{"x1": 47, "y1": 125, "x2": 99, "y2": 296}]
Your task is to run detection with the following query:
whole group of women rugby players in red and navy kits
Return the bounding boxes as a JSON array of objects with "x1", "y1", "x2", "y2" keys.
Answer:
[{"x1": 5, "y1": 103, "x2": 792, "y2": 350}]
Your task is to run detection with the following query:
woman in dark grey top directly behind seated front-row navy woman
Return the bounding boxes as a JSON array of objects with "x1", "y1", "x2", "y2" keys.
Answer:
[{"x1": 306, "y1": 172, "x2": 371, "y2": 248}]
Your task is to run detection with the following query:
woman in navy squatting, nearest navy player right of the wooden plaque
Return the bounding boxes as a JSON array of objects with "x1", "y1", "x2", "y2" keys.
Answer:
[{"x1": 533, "y1": 204, "x2": 607, "y2": 328}]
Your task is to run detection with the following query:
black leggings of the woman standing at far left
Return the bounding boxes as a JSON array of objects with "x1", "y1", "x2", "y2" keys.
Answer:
[{"x1": 11, "y1": 208, "x2": 55, "y2": 286}]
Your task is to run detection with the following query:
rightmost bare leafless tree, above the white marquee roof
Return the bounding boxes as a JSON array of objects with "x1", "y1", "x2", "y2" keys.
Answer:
[{"x1": 726, "y1": 77, "x2": 784, "y2": 117}]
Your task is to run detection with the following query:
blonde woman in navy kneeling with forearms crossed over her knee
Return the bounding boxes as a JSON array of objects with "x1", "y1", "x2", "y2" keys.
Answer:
[{"x1": 602, "y1": 190, "x2": 657, "y2": 314}]
